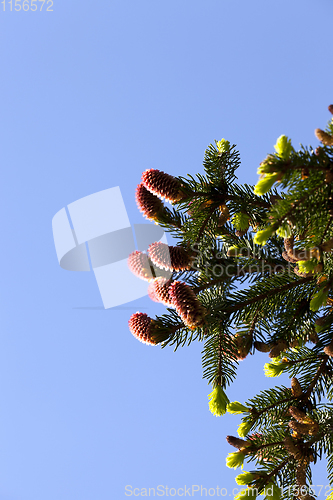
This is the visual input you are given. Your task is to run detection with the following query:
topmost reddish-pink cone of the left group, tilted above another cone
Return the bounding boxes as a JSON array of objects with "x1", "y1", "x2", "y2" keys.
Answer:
[{"x1": 141, "y1": 168, "x2": 188, "y2": 202}]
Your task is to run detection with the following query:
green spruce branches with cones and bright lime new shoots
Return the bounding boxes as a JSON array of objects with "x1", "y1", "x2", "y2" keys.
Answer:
[{"x1": 130, "y1": 105, "x2": 333, "y2": 500}]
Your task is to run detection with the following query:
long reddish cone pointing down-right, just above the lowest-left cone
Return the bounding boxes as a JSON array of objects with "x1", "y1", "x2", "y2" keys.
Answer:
[{"x1": 169, "y1": 281, "x2": 206, "y2": 328}]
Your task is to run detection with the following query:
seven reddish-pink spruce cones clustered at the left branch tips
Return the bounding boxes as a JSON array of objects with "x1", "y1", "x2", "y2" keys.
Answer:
[{"x1": 128, "y1": 169, "x2": 206, "y2": 345}]
